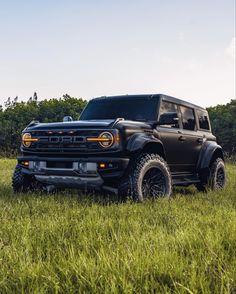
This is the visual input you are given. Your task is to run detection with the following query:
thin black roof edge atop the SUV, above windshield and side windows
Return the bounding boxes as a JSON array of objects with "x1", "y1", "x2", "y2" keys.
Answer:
[{"x1": 92, "y1": 94, "x2": 206, "y2": 110}]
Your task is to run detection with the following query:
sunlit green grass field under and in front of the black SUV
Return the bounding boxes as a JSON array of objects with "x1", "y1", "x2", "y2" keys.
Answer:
[{"x1": 0, "y1": 159, "x2": 236, "y2": 293}]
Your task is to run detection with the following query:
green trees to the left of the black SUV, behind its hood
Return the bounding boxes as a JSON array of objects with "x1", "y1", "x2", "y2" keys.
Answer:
[{"x1": 0, "y1": 93, "x2": 87, "y2": 155}]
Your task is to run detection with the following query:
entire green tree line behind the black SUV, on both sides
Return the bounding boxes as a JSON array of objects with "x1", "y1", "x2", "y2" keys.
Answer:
[{"x1": 0, "y1": 93, "x2": 236, "y2": 156}]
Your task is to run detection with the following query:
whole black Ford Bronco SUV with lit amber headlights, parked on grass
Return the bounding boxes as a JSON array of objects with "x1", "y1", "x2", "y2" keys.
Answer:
[{"x1": 12, "y1": 94, "x2": 226, "y2": 201}]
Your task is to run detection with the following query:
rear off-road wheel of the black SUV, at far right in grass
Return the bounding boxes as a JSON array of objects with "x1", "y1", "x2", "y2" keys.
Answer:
[{"x1": 195, "y1": 157, "x2": 226, "y2": 192}]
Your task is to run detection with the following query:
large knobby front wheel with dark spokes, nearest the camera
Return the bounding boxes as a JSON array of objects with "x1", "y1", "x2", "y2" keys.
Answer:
[{"x1": 118, "y1": 153, "x2": 172, "y2": 202}]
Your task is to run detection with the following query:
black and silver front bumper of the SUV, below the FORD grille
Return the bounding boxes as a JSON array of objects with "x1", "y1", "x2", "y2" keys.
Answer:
[{"x1": 17, "y1": 156, "x2": 129, "y2": 187}]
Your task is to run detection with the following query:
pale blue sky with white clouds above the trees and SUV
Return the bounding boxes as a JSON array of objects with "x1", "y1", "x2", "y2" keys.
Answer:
[{"x1": 0, "y1": 0, "x2": 235, "y2": 107}]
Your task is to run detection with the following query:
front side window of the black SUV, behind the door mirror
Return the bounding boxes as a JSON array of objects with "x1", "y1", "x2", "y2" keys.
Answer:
[{"x1": 159, "y1": 101, "x2": 179, "y2": 128}]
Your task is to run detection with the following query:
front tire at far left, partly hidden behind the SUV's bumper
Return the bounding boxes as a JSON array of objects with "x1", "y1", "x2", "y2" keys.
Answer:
[{"x1": 12, "y1": 164, "x2": 36, "y2": 193}]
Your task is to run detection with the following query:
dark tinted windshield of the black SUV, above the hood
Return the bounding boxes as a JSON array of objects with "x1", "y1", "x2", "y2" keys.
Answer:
[{"x1": 80, "y1": 97, "x2": 157, "y2": 121}]
